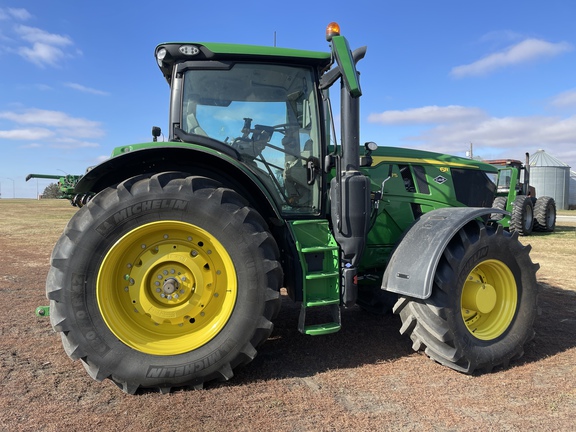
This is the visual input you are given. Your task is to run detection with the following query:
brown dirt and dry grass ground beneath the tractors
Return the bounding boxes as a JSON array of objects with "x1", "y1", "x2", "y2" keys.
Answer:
[{"x1": 0, "y1": 200, "x2": 576, "y2": 431}]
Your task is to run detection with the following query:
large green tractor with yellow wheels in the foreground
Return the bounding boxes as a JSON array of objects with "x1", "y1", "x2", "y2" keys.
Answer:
[{"x1": 43, "y1": 24, "x2": 538, "y2": 394}]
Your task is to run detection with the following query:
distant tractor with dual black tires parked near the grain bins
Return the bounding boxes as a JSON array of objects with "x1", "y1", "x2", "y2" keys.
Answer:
[{"x1": 486, "y1": 153, "x2": 556, "y2": 236}]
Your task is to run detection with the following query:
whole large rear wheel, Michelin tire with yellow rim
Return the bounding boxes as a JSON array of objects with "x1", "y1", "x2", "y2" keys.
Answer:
[{"x1": 47, "y1": 173, "x2": 283, "y2": 393}]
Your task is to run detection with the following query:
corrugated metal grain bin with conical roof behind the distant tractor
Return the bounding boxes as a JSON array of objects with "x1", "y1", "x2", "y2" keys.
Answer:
[{"x1": 530, "y1": 150, "x2": 570, "y2": 210}]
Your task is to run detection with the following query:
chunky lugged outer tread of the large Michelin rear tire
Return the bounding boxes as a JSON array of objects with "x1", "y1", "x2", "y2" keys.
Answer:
[{"x1": 46, "y1": 172, "x2": 283, "y2": 394}]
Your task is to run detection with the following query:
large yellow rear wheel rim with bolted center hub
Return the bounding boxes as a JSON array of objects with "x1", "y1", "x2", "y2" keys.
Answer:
[{"x1": 96, "y1": 221, "x2": 237, "y2": 356}]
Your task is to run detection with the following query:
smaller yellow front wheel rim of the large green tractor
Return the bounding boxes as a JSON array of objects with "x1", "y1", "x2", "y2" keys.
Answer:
[{"x1": 461, "y1": 260, "x2": 518, "y2": 340}]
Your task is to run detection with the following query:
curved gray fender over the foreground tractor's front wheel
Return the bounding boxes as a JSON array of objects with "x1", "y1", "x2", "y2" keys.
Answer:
[{"x1": 382, "y1": 207, "x2": 508, "y2": 299}]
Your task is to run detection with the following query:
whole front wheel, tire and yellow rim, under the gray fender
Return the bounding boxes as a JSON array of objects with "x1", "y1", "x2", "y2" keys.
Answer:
[{"x1": 394, "y1": 221, "x2": 538, "y2": 374}]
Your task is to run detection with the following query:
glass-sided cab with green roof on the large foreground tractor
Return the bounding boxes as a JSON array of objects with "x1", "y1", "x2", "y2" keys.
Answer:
[{"x1": 156, "y1": 43, "x2": 330, "y2": 215}]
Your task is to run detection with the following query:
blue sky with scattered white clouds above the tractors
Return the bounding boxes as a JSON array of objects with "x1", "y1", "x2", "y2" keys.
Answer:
[{"x1": 0, "y1": 0, "x2": 576, "y2": 198}]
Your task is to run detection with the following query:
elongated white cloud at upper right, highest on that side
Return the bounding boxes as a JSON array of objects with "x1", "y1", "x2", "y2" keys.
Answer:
[{"x1": 450, "y1": 39, "x2": 573, "y2": 78}]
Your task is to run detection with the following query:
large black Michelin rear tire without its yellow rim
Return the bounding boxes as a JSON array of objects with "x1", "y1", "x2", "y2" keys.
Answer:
[{"x1": 46, "y1": 172, "x2": 283, "y2": 394}]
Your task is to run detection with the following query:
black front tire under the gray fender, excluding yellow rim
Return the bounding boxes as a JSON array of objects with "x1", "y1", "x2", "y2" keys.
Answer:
[{"x1": 394, "y1": 221, "x2": 539, "y2": 374}]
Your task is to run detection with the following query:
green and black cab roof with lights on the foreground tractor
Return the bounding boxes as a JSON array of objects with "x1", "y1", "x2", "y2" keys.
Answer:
[{"x1": 154, "y1": 42, "x2": 332, "y2": 83}]
